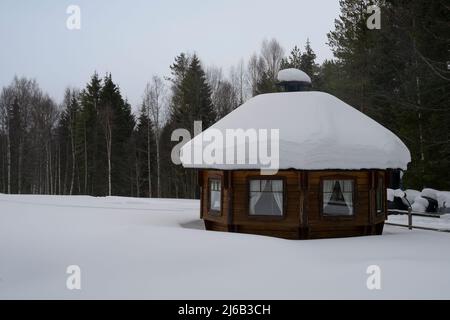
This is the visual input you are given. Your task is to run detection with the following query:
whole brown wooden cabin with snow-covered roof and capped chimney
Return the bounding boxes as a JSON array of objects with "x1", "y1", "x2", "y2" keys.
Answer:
[{"x1": 181, "y1": 70, "x2": 411, "y2": 239}]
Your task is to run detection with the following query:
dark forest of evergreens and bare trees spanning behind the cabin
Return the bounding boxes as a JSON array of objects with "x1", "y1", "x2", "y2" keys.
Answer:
[{"x1": 0, "y1": 0, "x2": 450, "y2": 198}]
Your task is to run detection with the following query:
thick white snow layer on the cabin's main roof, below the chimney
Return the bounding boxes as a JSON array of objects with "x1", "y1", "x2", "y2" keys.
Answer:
[{"x1": 181, "y1": 91, "x2": 411, "y2": 170}]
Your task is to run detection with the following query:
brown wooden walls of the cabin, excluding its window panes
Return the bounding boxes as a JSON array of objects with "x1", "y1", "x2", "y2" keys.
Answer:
[{"x1": 199, "y1": 170, "x2": 387, "y2": 239}]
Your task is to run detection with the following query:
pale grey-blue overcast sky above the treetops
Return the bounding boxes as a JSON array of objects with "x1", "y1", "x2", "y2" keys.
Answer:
[{"x1": 0, "y1": 0, "x2": 339, "y2": 107}]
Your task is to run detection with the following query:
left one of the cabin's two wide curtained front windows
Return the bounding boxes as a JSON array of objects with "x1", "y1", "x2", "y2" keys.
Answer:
[{"x1": 249, "y1": 179, "x2": 284, "y2": 216}]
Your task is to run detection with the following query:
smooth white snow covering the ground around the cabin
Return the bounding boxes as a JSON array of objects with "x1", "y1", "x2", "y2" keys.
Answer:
[{"x1": 0, "y1": 194, "x2": 450, "y2": 299}]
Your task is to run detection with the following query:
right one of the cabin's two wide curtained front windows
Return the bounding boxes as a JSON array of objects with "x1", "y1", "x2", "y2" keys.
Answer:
[{"x1": 322, "y1": 179, "x2": 354, "y2": 216}]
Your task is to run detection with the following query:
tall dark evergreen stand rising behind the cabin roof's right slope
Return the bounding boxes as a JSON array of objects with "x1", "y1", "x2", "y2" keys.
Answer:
[{"x1": 325, "y1": 0, "x2": 450, "y2": 189}]
